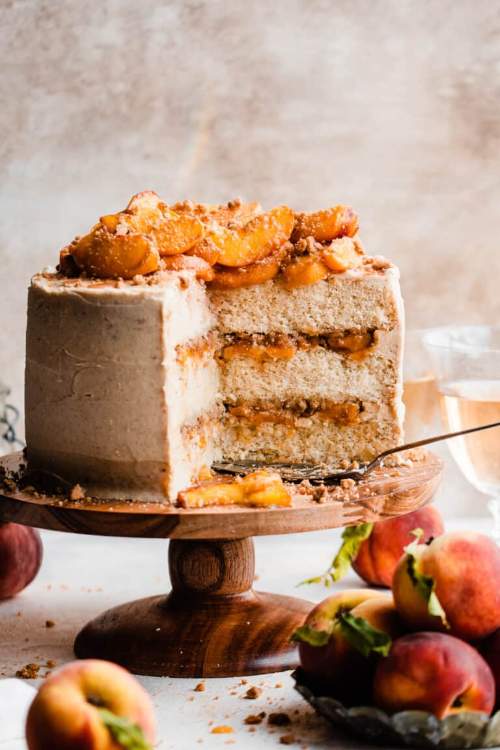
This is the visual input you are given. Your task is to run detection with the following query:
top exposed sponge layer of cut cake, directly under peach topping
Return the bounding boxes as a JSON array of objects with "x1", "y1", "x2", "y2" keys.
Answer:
[{"x1": 209, "y1": 261, "x2": 402, "y2": 335}]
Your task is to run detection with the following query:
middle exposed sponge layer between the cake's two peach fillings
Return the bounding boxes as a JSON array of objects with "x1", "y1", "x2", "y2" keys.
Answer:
[{"x1": 221, "y1": 329, "x2": 401, "y2": 403}]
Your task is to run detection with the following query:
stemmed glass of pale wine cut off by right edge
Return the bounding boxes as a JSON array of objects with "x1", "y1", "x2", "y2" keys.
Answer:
[{"x1": 424, "y1": 326, "x2": 500, "y2": 543}]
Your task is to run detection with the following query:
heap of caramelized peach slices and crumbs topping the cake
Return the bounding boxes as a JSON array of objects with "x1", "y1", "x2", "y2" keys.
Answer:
[{"x1": 53, "y1": 191, "x2": 389, "y2": 289}]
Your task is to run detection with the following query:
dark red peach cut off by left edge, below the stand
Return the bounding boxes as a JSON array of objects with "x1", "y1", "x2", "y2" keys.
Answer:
[{"x1": 0, "y1": 523, "x2": 43, "y2": 599}]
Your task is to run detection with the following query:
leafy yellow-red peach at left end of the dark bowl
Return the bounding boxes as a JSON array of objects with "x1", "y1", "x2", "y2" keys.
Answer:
[{"x1": 293, "y1": 589, "x2": 401, "y2": 703}]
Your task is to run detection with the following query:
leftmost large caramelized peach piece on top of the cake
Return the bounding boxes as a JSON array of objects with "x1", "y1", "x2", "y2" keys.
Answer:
[{"x1": 71, "y1": 229, "x2": 160, "y2": 279}]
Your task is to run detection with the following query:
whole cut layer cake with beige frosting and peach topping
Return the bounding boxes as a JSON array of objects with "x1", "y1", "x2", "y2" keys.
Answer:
[{"x1": 26, "y1": 193, "x2": 403, "y2": 504}]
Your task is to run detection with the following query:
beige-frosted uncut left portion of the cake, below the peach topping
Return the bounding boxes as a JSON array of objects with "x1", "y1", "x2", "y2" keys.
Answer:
[{"x1": 26, "y1": 274, "x2": 218, "y2": 501}]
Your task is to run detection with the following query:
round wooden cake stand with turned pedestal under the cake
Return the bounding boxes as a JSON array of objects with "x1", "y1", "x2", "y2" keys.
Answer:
[{"x1": 0, "y1": 453, "x2": 442, "y2": 677}]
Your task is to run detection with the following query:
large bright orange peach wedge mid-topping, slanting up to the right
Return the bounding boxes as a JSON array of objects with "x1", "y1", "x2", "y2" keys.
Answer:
[{"x1": 208, "y1": 206, "x2": 294, "y2": 268}]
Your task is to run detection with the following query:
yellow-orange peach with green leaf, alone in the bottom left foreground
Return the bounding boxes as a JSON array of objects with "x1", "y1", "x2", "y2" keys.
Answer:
[{"x1": 26, "y1": 659, "x2": 155, "y2": 750}]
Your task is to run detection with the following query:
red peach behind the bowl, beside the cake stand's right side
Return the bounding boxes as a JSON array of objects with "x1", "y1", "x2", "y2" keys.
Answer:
[{"x1": 352, "y1": 505, "x2": 444, "y2": 588}]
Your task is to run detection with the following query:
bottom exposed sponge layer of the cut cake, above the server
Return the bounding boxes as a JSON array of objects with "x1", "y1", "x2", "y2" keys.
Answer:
[{"x1": 222, "y1": 407, "x2": 402, "y2": 466}]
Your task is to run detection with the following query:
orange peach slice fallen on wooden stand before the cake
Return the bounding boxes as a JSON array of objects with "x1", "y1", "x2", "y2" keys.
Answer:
[{"x1": 178, "y1": 469, "x2": 292, "y2": 508}]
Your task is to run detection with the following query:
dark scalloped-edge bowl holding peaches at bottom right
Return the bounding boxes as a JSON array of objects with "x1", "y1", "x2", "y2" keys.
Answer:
[{"x1": 292, "y1": 669, "x2": 500, "y2": 750}]
